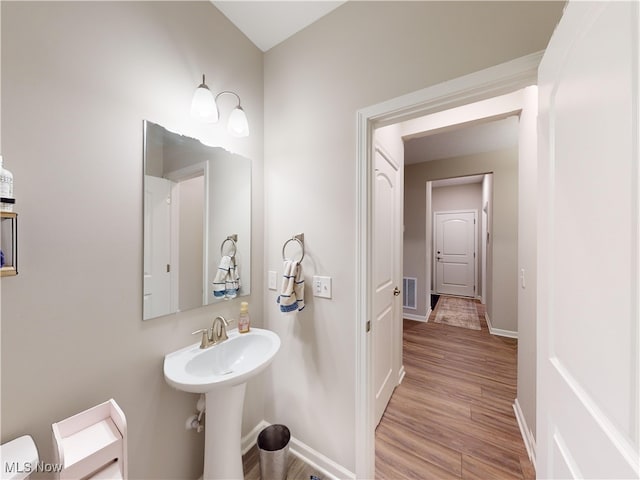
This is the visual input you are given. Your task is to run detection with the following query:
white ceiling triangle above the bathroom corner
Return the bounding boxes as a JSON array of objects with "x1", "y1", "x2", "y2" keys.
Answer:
[{"x1": 211, "y1": 0, "x2": 345, "y2": 52}]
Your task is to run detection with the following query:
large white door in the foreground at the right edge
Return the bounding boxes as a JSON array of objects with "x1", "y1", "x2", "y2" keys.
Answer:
[{"x1": 536, "y1": 2, "x2": 640, "y2": 479}]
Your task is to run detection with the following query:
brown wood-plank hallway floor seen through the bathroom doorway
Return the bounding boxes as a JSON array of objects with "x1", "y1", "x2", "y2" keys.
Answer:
[{"x1": 376, "y1": 303, "x2": 535, "y2": 480}]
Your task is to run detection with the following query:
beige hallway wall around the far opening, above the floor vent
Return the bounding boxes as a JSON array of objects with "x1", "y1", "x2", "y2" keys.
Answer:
[{"x1": 405, "y1": 149, "x2": 518, "y2": 332}]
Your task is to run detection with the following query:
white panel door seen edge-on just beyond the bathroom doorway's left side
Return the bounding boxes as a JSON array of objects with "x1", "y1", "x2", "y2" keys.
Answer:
[{"x1": 371, "y1": 148, "x2": 402, "y2": 425}]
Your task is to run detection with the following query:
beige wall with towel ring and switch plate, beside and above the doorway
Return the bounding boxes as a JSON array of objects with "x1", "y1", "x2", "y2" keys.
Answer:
[{"x1": 265, "y1": 2, "x2": 562, "y2": 470}]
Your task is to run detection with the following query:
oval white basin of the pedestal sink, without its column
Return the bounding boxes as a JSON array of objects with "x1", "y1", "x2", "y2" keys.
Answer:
[{"x1": 164, "y1": 328, "x2": 280, "y2": 393}]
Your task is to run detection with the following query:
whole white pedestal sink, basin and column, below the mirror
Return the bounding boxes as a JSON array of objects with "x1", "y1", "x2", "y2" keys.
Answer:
[{"x1": 164, "y1": 328, "x2": 280, "y2": 480}]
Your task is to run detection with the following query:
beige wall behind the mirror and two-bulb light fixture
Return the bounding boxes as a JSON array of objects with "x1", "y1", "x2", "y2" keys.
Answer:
[{"x1": 1, "y1": 1, "x2": 264, "y2": 479}]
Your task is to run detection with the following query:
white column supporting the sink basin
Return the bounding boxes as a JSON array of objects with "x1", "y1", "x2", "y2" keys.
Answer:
[{"x1": 203, "y1": 383, "x2": 247, "y2": 480}]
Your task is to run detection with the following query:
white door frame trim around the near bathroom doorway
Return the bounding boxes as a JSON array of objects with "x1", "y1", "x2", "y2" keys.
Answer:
[{"x1": 354, "y1": 52, "x2": 543, "y2": 479}]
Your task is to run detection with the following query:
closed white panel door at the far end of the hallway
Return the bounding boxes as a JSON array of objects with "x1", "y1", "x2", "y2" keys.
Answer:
[{"x1": 434, "y1": 211, "x2": 477, "y2": 297}]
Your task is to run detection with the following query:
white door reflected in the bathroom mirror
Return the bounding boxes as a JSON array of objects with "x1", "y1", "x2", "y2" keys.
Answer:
[{"x1": 142, "y1": 175, "x2": 173, "y2": 320}]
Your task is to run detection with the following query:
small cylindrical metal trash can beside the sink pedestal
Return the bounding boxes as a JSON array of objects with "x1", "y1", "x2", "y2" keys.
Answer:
[{"x1": 258, "y1": 424, "x2": 291, "y2": 480}]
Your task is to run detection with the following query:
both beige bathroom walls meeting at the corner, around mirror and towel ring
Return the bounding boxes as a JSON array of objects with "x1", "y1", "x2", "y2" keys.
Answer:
[{"x1": 1, "y1": 1, "x2": 562, "y2": 479}]
